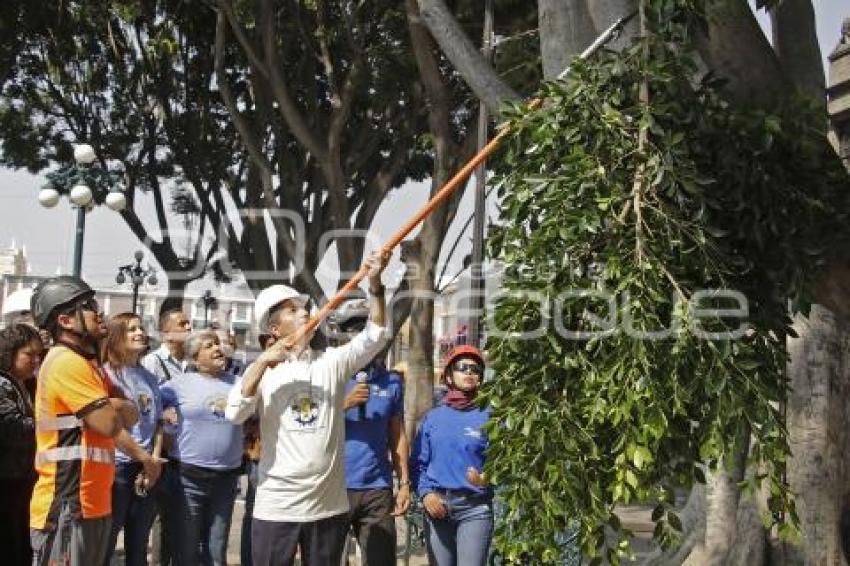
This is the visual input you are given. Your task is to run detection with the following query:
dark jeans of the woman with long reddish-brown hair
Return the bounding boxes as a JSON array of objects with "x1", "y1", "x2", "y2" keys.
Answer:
[{"x1": 106, "y1": 462, "x2": 162, "y2": 566}]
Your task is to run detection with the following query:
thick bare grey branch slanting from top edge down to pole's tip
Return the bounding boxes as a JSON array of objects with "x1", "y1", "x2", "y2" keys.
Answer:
[{"x1": 413, "y1": 0, "x2": 519, "y2": 114}]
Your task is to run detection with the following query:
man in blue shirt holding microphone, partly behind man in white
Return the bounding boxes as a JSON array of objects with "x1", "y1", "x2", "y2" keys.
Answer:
[{"x1": 330, "y1": 299, "x2": 410, "y2": 566}]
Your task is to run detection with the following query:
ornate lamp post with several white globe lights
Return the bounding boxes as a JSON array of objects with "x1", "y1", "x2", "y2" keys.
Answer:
[{"x1": 38, "y1": 144, "x2": 127, "y2": 277}]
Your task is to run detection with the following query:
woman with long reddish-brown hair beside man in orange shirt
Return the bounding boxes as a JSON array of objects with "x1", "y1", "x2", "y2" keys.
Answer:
[{"x1": 103, "y1": 313, "x2": 168, "y2": 566}]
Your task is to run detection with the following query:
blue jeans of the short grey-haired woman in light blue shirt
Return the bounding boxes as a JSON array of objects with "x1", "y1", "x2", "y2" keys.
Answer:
[{"x1": 172, "y1": 468, "x2": 239, "y2": 566}]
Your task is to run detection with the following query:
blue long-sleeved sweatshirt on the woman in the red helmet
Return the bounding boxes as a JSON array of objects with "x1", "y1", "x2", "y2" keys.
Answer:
[{"x1": 410, "y1": 405, "x2": 493, "y2": 497}]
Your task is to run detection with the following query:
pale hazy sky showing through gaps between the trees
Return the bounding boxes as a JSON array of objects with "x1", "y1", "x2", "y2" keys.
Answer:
[{"x1": 0, "y1": 0, "x2": 850, "y2": 298}]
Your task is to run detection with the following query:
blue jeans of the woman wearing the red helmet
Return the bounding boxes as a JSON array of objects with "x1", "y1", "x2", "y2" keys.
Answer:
[{"x1": 425, "y1": 490, "x2": 493, "y2": 566}]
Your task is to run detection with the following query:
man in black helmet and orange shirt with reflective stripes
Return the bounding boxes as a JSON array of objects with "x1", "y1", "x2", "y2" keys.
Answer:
[{"x1": 30, "y1": 276, "x2": 138, "y2": 566}]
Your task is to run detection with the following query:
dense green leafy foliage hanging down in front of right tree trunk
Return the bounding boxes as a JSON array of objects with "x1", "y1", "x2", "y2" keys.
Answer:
[{"x1": 486, "y1": 2, "x2": 850, "y2": 563}]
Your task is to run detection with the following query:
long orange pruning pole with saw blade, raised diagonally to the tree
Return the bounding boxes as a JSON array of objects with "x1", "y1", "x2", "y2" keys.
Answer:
[{"x1": 287, "y1": 12, "x2": 636, "y2": 344}]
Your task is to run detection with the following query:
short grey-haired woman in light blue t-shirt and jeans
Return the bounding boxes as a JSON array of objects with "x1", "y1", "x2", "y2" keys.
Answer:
[{"x1": 162, "y1": 330, "x2": 242, "y2": 566}]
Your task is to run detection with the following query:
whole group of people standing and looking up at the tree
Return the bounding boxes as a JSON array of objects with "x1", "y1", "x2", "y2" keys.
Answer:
[{"x1": 0, "y1": 254, "x2": 493, "y2": 566}]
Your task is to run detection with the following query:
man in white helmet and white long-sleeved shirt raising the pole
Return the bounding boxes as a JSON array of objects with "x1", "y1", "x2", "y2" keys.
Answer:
[{"x1": 225, "y1": 253, "x2": 389, "y2": 566}]
